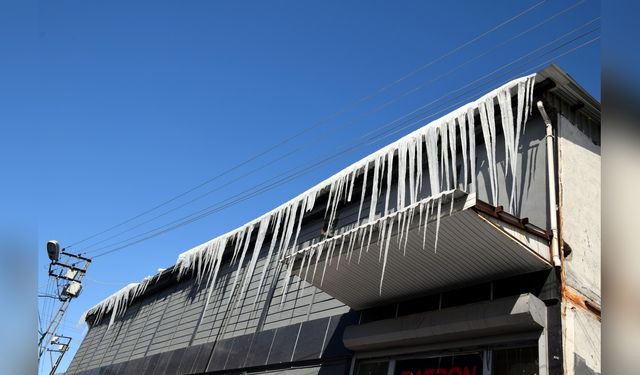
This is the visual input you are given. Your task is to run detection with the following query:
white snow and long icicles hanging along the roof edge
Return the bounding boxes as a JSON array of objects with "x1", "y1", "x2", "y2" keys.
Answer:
[{"x1": 88, "y1": 74, "x2": 535, "y2": 324}]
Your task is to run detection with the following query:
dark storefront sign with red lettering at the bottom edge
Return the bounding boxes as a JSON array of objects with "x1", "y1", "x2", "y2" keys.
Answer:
[{"x1": 395, "y1": 354, "x2": 482, "y2": 375}]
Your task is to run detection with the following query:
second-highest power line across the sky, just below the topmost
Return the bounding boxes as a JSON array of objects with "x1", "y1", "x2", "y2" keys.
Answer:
[{"x1": 83, "y1": 0, "x2": 586, "y2": 252}]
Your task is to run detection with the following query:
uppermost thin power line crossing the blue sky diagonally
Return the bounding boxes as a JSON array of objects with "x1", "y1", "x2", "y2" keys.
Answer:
[{"x1": 66, "y1": 0, "x2": 546, "y2": 253}]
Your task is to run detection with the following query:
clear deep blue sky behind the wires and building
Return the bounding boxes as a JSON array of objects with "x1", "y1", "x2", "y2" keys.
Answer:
[{"x1": 0, "y1": 0, "x2": 600, "y2": 369}]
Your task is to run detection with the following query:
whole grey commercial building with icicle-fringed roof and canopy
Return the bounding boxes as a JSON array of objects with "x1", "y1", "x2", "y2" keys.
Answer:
[{"x1": 67, "y1": 65, "x2": 601, "y2": 375}]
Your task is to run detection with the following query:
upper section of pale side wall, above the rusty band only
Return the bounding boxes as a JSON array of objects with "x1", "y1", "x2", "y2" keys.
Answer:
[{"x1": 558, "y1": 116, "x2": 601, "y2": 304}]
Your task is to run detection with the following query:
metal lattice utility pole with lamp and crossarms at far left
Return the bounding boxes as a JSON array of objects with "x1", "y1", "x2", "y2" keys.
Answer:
[{"x1": 38, "y1": 241, "x2": 91, "y2": 375}]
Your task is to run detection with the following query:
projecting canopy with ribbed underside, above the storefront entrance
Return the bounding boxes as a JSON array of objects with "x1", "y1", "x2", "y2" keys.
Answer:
[{"x1": 293, "y1": 191, "x2": 552, "y2": 310}]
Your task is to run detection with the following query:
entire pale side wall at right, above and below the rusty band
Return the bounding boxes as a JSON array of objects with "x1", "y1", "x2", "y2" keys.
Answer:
[{"x1": 557, "y1": 115, "x2": 602, "y2": 375}]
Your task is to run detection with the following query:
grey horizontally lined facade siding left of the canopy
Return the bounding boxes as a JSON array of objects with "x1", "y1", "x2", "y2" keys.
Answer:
[{"x1": 68, "y1": 244, "x2": 349, "y2": 373}]
